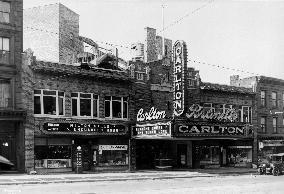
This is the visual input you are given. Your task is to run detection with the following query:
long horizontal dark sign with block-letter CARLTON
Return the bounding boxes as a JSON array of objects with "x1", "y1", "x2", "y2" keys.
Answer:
[{"x1": 177, "y1": 124, "x2": 251, "y2": 135}]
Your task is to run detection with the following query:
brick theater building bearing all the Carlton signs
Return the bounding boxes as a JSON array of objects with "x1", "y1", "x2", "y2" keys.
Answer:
[{"x1": 130, "y1": 40, "x2": 257, "y2": 169}]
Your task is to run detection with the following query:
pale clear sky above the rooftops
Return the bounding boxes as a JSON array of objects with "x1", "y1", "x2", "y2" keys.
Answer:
[{"x1": 23, "y1": 0, "x2": 284, "y2": 84}]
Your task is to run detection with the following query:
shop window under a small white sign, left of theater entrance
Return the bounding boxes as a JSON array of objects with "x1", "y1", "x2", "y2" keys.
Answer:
[{"x1": 97, "y1": 145, "x2": 128, "y2": 166}]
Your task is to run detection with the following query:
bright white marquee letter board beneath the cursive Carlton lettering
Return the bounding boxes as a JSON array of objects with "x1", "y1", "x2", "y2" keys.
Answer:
[{"x1": 132, "y1": 122, "x2": 171, "y2": 137}]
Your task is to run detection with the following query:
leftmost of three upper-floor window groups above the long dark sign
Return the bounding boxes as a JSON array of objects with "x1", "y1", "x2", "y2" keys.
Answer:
[{"x1": 34, "y1": 90, "x2": 65, "y2": 116}]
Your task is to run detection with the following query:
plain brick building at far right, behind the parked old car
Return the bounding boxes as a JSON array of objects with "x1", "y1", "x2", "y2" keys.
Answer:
[{"x1": 230, "y1": 75, "x2": 284, "y2": 159}]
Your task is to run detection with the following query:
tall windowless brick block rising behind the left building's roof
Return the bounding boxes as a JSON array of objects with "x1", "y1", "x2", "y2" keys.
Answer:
[{"x1": 24, "y1": 3, "x2": 83, "y2": 64}]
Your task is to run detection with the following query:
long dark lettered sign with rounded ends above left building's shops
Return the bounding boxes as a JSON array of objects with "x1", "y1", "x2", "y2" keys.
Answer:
[{"x1": 43, "y1": 123, "x2": 126, "y2": 134}]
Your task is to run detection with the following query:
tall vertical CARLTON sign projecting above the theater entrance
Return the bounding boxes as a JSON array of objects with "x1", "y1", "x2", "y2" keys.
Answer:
[{"x1": 173, "y1": 41, "x2": 186, "y2": 116}]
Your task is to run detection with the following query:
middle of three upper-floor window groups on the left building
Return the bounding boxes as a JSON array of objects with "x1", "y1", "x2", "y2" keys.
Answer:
[{"x1": 71, "y1": 93, "x2": 99, "y2": 117}]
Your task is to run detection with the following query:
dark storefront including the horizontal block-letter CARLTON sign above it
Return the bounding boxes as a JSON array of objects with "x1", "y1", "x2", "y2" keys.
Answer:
[{"x1": 174, "y1": 120, "x2": 253, "y2": 168}]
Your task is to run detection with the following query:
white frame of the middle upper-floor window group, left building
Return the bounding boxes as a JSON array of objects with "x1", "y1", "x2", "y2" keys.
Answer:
[{"x1": 71, "y1": 92, "x2": 100, "y2": 118}]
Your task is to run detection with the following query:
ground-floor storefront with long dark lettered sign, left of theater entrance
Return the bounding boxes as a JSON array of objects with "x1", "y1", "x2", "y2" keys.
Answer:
[{"x1": 35, "y1": 122, "x2": 129, "y2": 172}]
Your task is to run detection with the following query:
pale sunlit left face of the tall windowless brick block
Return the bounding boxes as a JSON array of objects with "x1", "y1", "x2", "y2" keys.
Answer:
[{"x1": 24, "y1": 4, "x2": 59, "y2": 62}]
